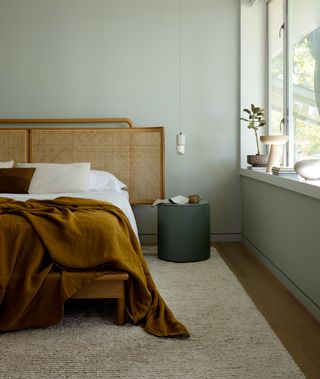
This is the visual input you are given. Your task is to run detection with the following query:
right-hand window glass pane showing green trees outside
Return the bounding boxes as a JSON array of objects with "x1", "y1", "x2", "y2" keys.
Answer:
[{"x1": 289, "y1": 0, "x2": 320, "y2": 161}]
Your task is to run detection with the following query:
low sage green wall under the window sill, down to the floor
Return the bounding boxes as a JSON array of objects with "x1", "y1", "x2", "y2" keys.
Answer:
[{"x1": 242, "y1": 177, "x2": 320, "y2": 320}]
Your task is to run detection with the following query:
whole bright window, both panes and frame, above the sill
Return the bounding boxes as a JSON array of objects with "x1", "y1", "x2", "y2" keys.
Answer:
[{"x1": 267, "y1": 0, "x2": 320, "y2": 166}]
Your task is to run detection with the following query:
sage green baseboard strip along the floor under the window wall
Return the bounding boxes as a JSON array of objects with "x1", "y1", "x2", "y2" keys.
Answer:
[{"x1": 242, "y1": 236, "x2": 320, "y2": 321}]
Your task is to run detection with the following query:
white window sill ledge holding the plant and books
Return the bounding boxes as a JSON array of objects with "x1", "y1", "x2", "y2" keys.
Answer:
[{"x1": 240, "y1": 168, "x2": 320, "y2": 199}]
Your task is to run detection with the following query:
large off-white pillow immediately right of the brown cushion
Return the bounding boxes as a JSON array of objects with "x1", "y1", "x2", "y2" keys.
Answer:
[{"x1": 17, "y1": 163, "x2": 90, "y2": 193}]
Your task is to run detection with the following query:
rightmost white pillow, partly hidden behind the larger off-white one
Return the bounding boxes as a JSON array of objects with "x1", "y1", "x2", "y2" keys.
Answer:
[{"x1": 89, "y1": 170, "x2": 127, "y2": 192}]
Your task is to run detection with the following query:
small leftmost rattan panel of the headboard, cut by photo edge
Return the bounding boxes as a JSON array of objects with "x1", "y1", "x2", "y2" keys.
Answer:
[{"x1": 0, "y1": 129, "x2": 28, "y2": 162}]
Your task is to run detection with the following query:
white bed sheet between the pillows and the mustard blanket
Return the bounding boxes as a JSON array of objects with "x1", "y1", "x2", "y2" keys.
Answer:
[{"x1": 0, "y1": 191, "x2": 138, "y2": 237}]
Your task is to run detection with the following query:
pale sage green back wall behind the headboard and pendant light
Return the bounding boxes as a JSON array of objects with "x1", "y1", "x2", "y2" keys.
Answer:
[{"x1": 0, "y1": 0, "x2": 241, "y2": 240}]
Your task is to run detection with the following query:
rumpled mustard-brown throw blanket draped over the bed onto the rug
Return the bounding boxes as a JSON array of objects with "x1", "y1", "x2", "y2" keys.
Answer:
[{"x1": 0, "y1": 197, "x2": 188, "y2": 336}]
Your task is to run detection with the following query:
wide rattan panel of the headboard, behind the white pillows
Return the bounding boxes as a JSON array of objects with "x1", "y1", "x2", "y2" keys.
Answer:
[{"x1": 30, "y1": 128, "x2": 163, "y2": 204}]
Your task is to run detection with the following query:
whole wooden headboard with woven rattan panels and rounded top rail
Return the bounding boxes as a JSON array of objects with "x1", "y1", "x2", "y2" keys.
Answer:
[{"x1": 0, "y1": 118, "x2": 164, "y2": 205}]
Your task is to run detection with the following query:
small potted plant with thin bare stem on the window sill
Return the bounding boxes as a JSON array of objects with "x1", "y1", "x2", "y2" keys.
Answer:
[{"x1": 240, "y1": 104, "x2": 268, "y2": 167}]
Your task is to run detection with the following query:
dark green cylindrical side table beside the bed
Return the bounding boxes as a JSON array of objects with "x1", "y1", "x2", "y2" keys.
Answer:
[{"x1": 158, "y1": 201, "x2": 210, "y2": 262}]
